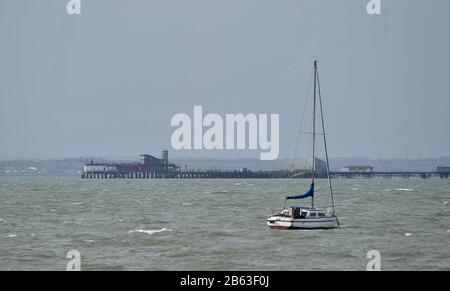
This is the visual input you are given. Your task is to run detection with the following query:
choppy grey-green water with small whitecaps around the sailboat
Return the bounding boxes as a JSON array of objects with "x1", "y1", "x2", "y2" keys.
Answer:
[{"x1": 0, "y1": 177, "x2": 450, "y2": 270}]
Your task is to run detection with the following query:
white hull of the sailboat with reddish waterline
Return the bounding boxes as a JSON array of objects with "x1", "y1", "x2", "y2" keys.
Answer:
[{"x1": 267, "y1": 216, "x2": 338, "y2": 229}]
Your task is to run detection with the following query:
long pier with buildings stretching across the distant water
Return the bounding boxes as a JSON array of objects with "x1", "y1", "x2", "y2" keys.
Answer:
[{"x1": 81, "y1": 150, "x2": 450, "y2": 179}]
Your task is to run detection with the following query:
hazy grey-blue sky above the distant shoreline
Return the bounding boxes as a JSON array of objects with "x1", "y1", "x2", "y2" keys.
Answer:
[{"x1": 0, "y1": 0, "x2": 450, "y2": 159}]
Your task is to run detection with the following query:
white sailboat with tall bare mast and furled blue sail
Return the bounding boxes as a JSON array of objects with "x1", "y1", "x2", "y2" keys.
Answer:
[{"x1": 267, "y1": 60, "x2": 339, "y2": 230}]
